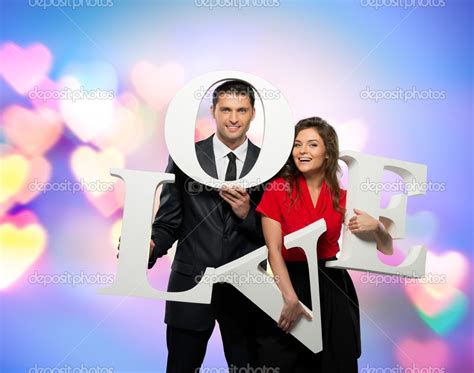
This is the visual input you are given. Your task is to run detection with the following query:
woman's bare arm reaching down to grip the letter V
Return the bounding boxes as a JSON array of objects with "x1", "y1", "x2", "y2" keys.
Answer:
[{"x1": 262, "y1": 216, "x2": 311, "y2": 333}]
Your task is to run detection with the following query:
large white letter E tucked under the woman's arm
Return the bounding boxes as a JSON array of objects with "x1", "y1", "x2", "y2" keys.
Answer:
[{"x1": 326, "y1": 151, "x2": 427, "y2": 277}]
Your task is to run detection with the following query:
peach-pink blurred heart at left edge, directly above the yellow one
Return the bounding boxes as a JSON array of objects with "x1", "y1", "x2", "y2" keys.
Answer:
[{"x1": 2, "y1": 105, "x2": 63, "y2": 156}]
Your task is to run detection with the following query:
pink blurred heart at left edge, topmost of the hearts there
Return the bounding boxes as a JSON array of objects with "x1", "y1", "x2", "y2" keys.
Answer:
[{"x1": 0, "y1": 42, "x2": 52, "y2": 95}]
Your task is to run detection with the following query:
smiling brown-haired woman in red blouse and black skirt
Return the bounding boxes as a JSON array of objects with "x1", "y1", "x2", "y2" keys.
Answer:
[{"x1": 257, "y1": 117, "x2": 393, "y2": 373}]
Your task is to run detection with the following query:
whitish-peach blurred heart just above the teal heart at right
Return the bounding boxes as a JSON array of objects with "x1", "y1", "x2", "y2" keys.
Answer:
[{"x1": 405, "y1": 251, "x2": 468, "y2": 317}]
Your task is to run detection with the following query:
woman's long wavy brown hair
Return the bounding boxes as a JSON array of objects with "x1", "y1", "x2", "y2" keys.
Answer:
[{"x1": 279, "y1": 117, "x2": 345, "y2": 214}]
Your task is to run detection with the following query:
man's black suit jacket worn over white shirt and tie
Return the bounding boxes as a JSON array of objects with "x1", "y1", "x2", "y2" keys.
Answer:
[{"x1": 149, "y1": 136, "x2": 264, "y2": 330}]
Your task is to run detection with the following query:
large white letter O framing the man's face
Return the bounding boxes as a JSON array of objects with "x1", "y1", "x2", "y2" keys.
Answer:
[{"x1": 165, "y1": 71, "x2": 294, "y2": 189}]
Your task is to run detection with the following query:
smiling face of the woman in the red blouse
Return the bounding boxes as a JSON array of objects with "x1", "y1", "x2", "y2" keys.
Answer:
[{"x1": 292, "y1": 128, "x2": 326, "y2": 176}]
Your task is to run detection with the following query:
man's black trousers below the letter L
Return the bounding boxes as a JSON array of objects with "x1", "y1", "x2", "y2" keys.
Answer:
[{"x1": 166, "y1": 284, "x2": 256, "y2": 373}]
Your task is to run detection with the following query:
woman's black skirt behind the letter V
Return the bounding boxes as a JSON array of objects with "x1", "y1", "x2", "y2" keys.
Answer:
[{"x1": 257, "y1": 260, "x2": 361, "y2": 373}]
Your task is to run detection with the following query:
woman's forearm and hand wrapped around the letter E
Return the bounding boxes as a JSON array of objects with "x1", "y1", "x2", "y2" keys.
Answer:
[{"x1": 349, "y1": 209, "x2": 393, "y2": 255}]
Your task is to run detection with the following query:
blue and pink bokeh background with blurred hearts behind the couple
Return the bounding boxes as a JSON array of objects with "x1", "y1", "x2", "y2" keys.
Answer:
[{"x1": 0, "y1": 0, "x2": 473, "y2": 373}]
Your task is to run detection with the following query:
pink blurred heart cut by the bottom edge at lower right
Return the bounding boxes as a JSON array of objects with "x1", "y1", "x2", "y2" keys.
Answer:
[{"x1": 395, "y1": 338, "x2": 450, "y2": 372}]
